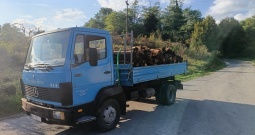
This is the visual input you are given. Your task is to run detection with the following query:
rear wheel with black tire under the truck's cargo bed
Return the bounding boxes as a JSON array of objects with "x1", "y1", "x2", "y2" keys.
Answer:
[{"x1": 156, "y1": 83, "x2": 176, "y2": 105}]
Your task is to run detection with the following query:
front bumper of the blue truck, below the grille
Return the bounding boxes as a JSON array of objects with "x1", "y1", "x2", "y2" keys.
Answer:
[{"x1": 21, "y1": 98, "x2": 75, "y2": 125}]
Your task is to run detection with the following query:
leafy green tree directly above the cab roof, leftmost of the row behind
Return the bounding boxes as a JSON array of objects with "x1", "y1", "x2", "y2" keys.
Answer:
[{"x1": 84, "y1": 8, "x2": 113, "y2": 29}]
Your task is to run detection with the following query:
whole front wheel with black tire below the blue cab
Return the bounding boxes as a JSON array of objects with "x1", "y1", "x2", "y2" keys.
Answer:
[{"x1": 97, "y1": 99, "x2": 120, "y2": 132}]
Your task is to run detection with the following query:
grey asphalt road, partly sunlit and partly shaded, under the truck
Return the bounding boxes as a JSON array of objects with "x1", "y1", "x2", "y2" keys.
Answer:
[{"x1": 0, "y1": 61, "x2": 255, "y2": 135}]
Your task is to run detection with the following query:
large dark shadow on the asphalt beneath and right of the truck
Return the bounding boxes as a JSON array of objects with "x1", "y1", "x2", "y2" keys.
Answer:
[{"x1": 53, "y1": 98, "x2": 255, "y2": 135}]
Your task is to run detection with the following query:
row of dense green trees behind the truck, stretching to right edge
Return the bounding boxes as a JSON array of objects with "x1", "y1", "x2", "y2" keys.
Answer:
[{"x1": 84, "y1": 0, "x2": 255, "y2": 58}]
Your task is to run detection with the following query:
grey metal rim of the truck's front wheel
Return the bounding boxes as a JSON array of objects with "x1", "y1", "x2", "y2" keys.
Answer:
[{"x1": 103, "y1": 106, "x2": 116, "y2": 124}]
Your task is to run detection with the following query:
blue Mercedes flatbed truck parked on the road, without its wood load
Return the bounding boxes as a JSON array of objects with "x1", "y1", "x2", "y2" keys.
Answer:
[{"x1": 20, "y1": 27, "x2": 187, "y2": 131}]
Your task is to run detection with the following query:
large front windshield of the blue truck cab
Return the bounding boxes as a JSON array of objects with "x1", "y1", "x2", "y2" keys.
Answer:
[{"x1": 26, "y1": 31, "x2": 70, "y2": 66}]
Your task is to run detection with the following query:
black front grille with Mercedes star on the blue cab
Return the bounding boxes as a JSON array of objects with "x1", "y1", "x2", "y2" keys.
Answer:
[{"x1": 25, "y1": 85, "x2": 62, "y2": 103}]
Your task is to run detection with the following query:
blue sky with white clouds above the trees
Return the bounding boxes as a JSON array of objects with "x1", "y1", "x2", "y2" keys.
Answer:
[{"x1": 0, "y1": 0, "x2": 255, "y2": 31}]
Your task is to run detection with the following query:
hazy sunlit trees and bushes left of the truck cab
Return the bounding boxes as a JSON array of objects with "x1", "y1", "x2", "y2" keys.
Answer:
[{"x1": 0, "y1": 23, "x2": 43, "y2": 117}]
